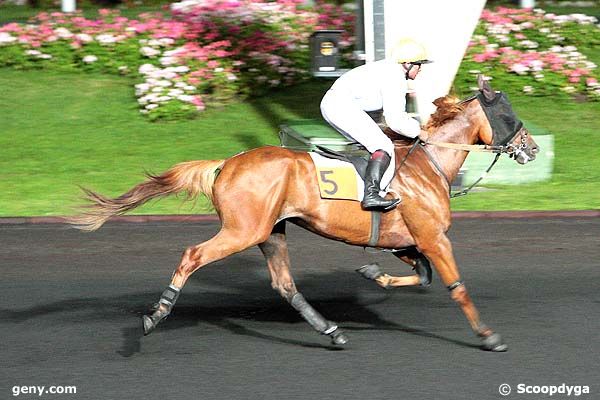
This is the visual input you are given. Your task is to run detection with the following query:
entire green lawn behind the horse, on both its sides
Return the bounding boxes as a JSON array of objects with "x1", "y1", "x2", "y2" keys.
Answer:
[{"x1": 0, "y1": 69, "x2": 600, "y2": 216}]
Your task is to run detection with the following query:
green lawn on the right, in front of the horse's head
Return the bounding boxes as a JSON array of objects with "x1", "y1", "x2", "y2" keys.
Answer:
[{"x1": 452, "y1": 96, "x2": 600, "y2": 210}]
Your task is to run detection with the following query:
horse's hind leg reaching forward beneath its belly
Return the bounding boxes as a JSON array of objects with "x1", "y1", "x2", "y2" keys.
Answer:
[{"x1": 258, "y1": 221, "x2": 348, "y2": 345}]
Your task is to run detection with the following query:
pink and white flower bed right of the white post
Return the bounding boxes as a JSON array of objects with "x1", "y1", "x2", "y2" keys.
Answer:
[{"x1": 455, "y1": 7, "x2": 600, "y2": 100}]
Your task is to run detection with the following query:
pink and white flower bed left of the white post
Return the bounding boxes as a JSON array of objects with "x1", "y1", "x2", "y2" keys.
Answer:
[{"x1": 0, "y1": 0, "x2": 354, "y2": 119}]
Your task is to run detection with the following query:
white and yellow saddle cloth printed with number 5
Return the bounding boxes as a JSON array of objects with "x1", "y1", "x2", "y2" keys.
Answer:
[{"x1": 308, "y1": 152, "x2": 389, "y2": 201}]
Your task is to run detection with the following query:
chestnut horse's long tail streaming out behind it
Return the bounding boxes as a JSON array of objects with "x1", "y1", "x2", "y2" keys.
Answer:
[{"x1": 67, "y1": 160, "x2": 225, "y2": 231}]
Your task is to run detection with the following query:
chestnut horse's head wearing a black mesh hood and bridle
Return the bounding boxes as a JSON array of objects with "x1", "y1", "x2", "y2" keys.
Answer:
[{"x1": 475, "y1": 75, "x2": 539, "y2": 164}]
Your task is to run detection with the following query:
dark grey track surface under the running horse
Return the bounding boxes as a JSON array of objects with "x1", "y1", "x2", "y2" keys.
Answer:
[{"x1": 0, "y1": 218, "x2": 600, "y2": 400}]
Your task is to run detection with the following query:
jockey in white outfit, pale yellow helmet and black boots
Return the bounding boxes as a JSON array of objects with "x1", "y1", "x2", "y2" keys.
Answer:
[{"x1": 321, "y1": 39, "x2": 431, "y2": 210}]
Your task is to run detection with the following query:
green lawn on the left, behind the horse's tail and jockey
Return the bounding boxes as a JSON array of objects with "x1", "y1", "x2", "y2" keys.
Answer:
[{"x1": 0, "y1": 69, "x2": 326, "y2": 216}]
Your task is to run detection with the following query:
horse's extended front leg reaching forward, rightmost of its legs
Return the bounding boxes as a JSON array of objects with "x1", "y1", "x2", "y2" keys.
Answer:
[{"x1": 415, "y1": 232, "x2": 508, "y2": 351}]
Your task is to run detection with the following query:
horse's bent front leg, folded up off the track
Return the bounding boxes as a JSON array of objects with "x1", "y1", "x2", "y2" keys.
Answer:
[{"x1": 356, "y1": 247, "x2": 432, "y2": 289}]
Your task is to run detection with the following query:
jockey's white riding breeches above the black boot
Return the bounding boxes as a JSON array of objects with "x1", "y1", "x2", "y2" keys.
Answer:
[{"x1": 321, "y1": 90, "x2": 396, "y2": 190}]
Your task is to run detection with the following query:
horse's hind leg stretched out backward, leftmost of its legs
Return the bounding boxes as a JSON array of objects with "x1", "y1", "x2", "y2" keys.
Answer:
[{"x1": 142, "y1": 228, "x2": 268, "y2": 335}]
